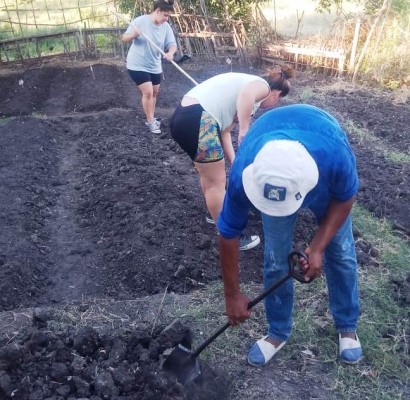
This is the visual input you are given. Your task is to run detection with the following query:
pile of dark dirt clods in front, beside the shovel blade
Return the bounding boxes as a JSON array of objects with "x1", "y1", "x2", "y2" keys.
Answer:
[{"x1": 0, "y1": 309, "x2": 230, "y2": 400}]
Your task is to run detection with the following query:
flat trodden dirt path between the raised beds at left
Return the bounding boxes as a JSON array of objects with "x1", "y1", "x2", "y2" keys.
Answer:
[{"x1": 38, "y1": 119, "x2": 100, "y2": 305}]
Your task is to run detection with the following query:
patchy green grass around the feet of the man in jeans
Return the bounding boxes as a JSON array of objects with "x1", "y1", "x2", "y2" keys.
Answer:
[{"x1": 185, "y1": 206, "x2": 410, "y2": 400}]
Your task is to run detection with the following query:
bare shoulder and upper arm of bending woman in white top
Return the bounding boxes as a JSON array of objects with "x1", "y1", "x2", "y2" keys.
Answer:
[{"x1": 236, "y1": 81, "x2": 270, "y2": 143}]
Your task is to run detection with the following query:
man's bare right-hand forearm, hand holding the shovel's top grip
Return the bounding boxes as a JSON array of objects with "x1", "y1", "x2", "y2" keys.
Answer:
[{"x1": 304, "y1": 197, "x2": 354, "y2": 280}]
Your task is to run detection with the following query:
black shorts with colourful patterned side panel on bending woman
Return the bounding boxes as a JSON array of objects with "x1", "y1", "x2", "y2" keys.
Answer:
[{"x1": 170, "y1": 104, "x2": 224, "y2": 163}]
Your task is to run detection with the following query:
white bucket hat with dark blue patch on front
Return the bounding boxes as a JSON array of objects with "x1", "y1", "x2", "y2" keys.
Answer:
[{"x1": 242, "y1": 140, "x2": 319, "y2": 217}]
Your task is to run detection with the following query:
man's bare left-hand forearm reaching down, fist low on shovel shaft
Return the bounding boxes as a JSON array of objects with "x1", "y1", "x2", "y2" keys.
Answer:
[{"x1": 219, "y1": 236, "x2": 251, "y2": 325}]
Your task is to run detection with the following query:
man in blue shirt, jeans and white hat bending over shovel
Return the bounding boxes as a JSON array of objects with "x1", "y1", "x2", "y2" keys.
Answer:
[{"x1": 218, "y1": 104, "x2": 362, "y2": 366}]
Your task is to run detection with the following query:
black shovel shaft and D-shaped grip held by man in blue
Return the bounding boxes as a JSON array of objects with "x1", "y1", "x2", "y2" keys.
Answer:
[{"x1": 192, "y1": 251, "x2": 312, "y2": 357}]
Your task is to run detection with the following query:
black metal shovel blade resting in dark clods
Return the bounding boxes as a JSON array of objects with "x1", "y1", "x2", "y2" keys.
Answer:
[{"x1": 162, "y1": 344, "x2": 202, "y2": 386}]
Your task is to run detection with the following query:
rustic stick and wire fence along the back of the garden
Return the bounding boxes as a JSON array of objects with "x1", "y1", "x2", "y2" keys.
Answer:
[{"x1": 0, "y1": 0, "x2": 396, "y2": 81}]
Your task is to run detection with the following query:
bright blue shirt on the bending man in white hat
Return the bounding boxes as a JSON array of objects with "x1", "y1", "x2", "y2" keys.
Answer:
[{"x1": 217, "y1": 104, "x2": 359, "y2": 239}]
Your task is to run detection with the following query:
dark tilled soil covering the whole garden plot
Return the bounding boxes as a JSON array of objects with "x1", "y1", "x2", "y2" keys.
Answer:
[{"x1": 0, "y1": 57, "x2": 410, "y2": 400}]
